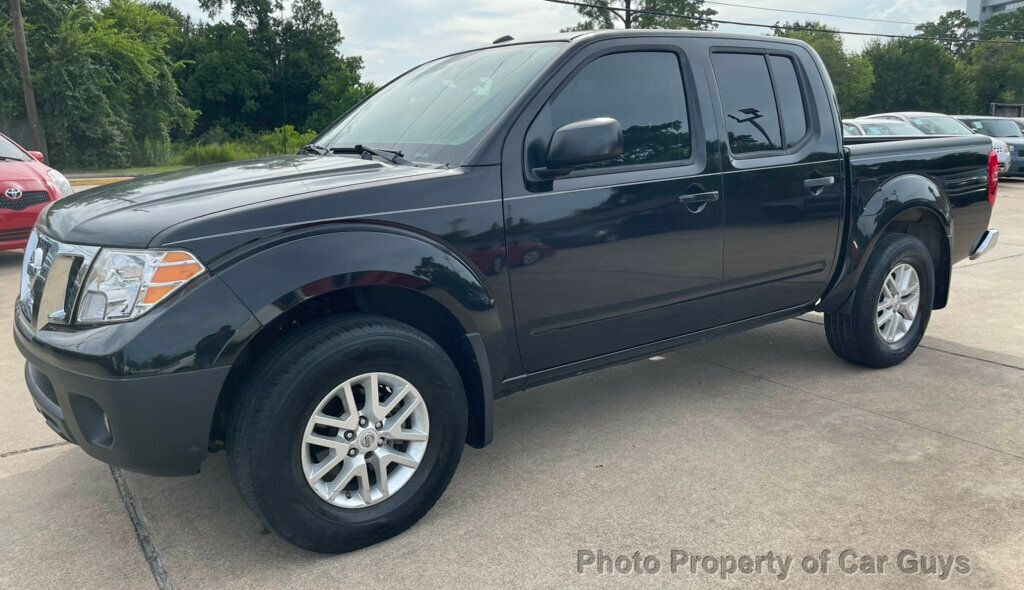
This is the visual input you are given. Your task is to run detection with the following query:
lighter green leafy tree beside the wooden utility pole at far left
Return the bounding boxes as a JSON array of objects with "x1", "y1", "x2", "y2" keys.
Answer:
[{"x1": 0, "y1": 0, "x2": 196, "y2": 167}]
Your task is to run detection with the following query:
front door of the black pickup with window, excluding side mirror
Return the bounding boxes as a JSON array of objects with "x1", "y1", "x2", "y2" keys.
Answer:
[{"x1": 504, "y1": 40, "x2": 723, "y2": 372}]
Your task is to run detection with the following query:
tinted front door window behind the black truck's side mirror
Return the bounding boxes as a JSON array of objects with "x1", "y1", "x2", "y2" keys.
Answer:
[{"x1": 539, "y1": 51, "x2": 692, "y2": 168}]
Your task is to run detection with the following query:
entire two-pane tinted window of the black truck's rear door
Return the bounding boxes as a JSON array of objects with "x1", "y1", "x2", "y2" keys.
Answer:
[{"x1": 712, "y1": 53, "x2": 808, "y2": 154}]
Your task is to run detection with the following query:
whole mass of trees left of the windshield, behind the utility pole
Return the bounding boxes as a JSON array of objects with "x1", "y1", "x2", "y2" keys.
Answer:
[{"x1": 0, "y1": 0, "x2": 374, "y2": 168}]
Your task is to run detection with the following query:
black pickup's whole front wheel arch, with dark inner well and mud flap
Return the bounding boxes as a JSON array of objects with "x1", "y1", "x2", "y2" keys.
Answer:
[{"x1": 210, "y1": 227, "x2": 503, "y2": 449}]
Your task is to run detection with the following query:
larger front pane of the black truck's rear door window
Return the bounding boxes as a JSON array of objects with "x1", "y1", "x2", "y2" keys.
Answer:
[{"x1": 712, "y1": 53, "x2": 782, "y2": 154}]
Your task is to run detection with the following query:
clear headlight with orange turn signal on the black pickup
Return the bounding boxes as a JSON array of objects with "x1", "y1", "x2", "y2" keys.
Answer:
[{"x1": 77, "y1": 248, "x2": 206, "y2": 324}]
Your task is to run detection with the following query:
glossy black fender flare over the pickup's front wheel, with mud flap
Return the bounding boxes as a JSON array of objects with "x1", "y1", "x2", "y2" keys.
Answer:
[{"x1": 211, "y1": 223, "x2": 504, "y2": 447}]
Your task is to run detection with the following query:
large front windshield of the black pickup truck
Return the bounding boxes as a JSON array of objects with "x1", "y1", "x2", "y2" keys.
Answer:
[{"x1": 317, "y1": 43, "x2": 564, "y2": 166}]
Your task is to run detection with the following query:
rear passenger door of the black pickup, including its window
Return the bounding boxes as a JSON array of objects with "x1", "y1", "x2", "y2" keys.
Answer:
[{"x1": 710, "y1": 43, "x2": 845, "y2": 321}]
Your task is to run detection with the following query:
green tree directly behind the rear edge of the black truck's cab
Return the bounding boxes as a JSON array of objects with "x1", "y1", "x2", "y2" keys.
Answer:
[{"x1": 774, "y1": 20, "x2": 874, "y2": 117}]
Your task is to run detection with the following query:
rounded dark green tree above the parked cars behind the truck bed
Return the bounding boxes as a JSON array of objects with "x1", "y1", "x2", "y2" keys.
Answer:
[{"x1": 863, "y1": 39, "x2": 975, "y2": 113}]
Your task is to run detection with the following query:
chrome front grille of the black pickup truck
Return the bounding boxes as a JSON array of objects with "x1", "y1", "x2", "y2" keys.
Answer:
[{"x1": 17, "y1": 231, "x2": 99, "y2": 330}]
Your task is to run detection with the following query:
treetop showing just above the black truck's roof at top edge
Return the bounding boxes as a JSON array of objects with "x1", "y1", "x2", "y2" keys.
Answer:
[{"x1": 568, "y1": 0, "x2": 718, "y2": 31}]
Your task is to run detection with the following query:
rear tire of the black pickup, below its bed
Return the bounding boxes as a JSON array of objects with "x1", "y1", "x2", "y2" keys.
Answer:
[{"x1": 825, "y1": 234, "x2": 935, "y2": 369}]
